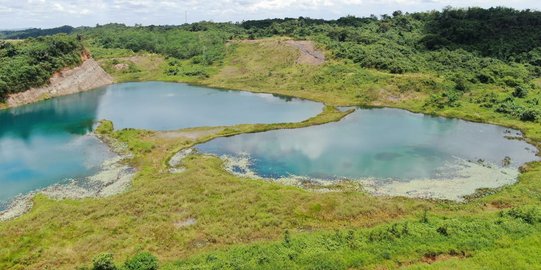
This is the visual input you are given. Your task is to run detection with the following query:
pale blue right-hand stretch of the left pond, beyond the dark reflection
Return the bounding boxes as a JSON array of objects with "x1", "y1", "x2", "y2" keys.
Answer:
[{"x1": 93, "y1": 82, "x2": 323, "y2": 130}]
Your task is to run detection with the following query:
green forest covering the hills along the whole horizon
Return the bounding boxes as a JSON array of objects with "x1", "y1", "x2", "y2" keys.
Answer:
[{"x1": 0, "y1": 7, "x2": 541, "y2": 121}]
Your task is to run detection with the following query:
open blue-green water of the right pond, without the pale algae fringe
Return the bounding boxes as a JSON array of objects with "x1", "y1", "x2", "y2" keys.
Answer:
[{"x1": 197, "y1": 109, "x2": 536, "y2": 181}]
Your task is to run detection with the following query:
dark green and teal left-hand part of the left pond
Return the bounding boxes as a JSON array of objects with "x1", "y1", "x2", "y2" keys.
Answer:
[{"x1": 0, "y1": 88, "x2": 112, "y2": 205}]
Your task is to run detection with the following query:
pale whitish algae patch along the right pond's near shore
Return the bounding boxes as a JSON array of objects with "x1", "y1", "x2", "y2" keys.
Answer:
[{"x1": 211, "y1": 153, "x2": 519, "y2": 202}]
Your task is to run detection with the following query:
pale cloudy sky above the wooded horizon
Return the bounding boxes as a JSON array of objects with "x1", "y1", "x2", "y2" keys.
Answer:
[{"x1": 0, "y1": 0, "x2": 541, "y2": 29}]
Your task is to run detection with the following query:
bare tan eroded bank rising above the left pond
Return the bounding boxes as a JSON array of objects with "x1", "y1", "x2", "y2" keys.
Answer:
[{"x1": 6, "y1": 58, "x2": 113, "y2": 107}]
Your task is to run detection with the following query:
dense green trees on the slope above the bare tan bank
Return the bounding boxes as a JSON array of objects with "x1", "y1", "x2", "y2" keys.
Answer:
[{"x1": 0, "y1": 34, "x2": 83, "y2": 100}]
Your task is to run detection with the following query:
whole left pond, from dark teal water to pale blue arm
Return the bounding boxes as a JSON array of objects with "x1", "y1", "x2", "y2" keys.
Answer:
[{"x1": 0, "y1": 82, "x2": 323, "y2": 210}]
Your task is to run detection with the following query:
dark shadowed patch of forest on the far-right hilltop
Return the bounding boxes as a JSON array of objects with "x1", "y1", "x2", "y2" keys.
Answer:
[{"x1": 423, "y1": 7, "x2": 541, "y2": 60}]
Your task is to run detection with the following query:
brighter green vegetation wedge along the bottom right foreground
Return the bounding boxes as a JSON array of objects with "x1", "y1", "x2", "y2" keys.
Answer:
[{"x1": 164, "y1": 208, "x2": 541, "y2": 269}]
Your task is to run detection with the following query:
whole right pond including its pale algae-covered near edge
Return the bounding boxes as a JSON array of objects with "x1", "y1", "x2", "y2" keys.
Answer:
[{"x1": 196, "y1": 108, "x2": 538, "y2": 200}]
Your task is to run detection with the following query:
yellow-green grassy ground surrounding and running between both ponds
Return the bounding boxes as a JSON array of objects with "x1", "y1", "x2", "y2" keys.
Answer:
[{"x1": 0, "y1": 39, "x2": 541, "y2": 269}]
